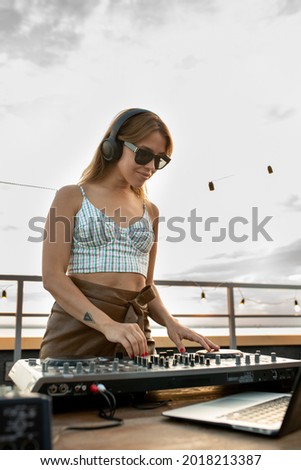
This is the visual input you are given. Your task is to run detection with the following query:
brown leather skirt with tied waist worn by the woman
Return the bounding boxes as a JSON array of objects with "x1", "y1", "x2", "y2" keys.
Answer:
[{"x1": 40, "y1": 276, "x2": 156, "y2": 359}]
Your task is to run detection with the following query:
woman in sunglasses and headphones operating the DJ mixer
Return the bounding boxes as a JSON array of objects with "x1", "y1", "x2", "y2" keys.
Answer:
[{"x1": 40, "y1": 108, "x2": 219, "y2": 359}]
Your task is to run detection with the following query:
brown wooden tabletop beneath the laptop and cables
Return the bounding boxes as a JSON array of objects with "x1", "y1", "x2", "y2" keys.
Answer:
[{"x1": 53, "y1": 386, "x2": 301, "y2": 450}]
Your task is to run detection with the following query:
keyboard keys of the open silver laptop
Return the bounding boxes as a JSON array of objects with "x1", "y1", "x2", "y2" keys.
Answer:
[{"x1": 219, "y1": 397, "x2": 290, "y2": 424}]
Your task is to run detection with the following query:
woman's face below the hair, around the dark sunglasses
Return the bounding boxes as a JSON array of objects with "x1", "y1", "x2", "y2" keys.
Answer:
[{"x1": 117, "y1": 131, "x2": 166, "y2": 188}]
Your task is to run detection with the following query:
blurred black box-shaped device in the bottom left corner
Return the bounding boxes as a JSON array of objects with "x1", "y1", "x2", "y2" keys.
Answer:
[{"x1": 0, "y1": 392, "x2": 52, "y2": 450}]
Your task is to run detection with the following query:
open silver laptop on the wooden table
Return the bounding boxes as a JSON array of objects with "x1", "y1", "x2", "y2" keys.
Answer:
[{"x1": 162, "y1": 368, "x2": 301, "y2": 437}]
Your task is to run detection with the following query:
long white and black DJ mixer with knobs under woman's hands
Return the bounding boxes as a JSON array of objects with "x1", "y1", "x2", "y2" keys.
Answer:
[{"x1": 9, "y1": 349, "x2": 301, "y2": 397}]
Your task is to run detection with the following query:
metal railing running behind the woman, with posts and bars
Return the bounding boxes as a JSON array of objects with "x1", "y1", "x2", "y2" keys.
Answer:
[{"x1": 0, "y1": 274, "x2": 301, "y2": 362}]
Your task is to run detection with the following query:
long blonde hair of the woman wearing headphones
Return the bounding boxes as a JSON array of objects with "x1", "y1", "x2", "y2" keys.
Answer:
[{"x1": 79, "y1": 109, "x2": 173, "y2": 199}]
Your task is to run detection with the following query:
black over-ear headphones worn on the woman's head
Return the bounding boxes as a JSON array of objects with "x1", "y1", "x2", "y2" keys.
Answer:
[{"x1": 101, "y1": 108, "x2": 149, "y2": 162}]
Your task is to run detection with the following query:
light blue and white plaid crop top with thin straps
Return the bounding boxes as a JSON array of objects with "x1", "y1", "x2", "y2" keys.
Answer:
[{"x1": 68, "y1": 186, "x2": 155, "y2": 277}]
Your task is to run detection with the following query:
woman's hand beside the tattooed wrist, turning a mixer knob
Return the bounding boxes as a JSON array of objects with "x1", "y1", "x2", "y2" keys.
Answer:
[{"x1": 102, "y1": 321, "x2": 148, "y2": 358}]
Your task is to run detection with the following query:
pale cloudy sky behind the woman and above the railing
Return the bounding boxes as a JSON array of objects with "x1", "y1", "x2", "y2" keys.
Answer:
[{"x1": 0, "y1": 0, "x2": 301, "y2": 320}]
